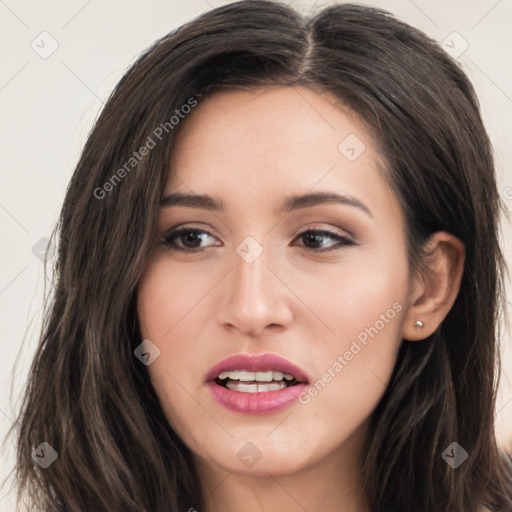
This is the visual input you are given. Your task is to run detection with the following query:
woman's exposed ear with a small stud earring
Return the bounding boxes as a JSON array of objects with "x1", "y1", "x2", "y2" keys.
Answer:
[{"x1": 402, "y1": 231, "x2": 465, "y2": 341}]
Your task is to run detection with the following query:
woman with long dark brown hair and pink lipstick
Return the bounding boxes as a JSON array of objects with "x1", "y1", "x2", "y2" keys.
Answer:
[{"x1": 7, "y1": 1, "x2": 512, "y2": 512}]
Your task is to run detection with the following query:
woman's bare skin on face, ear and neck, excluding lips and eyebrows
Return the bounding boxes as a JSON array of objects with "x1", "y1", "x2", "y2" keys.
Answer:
[{"x1": 138, "y1": 87, "x2": 464, "y2": 512}]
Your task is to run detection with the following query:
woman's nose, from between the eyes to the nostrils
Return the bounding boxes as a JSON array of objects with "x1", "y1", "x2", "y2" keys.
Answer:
[{"x1": 218, "y1": 242, "x2": 293, "y2": 337}]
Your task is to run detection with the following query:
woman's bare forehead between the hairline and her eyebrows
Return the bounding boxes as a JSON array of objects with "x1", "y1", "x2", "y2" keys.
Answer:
[{"x1": 164, "y1": 87, "x2": 396, "y2": 223}]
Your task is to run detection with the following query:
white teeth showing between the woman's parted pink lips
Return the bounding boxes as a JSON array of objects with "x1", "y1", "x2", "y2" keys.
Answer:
[{"x1": 215, "y1": 370, "x2": 300, "y2": 393}]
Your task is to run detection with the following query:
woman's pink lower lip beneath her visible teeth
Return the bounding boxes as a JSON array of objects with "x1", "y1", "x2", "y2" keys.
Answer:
[{"x1": 208, "y1": 381, "x2": 308, "y2": 414}]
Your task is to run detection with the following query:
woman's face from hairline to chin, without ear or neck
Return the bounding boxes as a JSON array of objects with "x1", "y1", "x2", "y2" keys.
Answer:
[{"x1": 138, "y1": 87, "x2": 411, "y2": 480}]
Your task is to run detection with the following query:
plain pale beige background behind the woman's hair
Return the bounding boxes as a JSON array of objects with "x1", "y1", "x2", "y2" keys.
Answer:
[{"x1": 0, "y1": 0, "x2": 512, "y2": 512}]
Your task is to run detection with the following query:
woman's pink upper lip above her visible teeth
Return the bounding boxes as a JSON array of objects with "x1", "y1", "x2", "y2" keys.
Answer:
[{"x1": 206, "y1": 354, "x2": 310, "y2": 383}]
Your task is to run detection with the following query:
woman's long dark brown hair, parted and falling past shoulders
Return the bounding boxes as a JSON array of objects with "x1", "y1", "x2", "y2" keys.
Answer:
[{"x1": 5, "y1": 1, "x2": 512, "y2": 512}]
